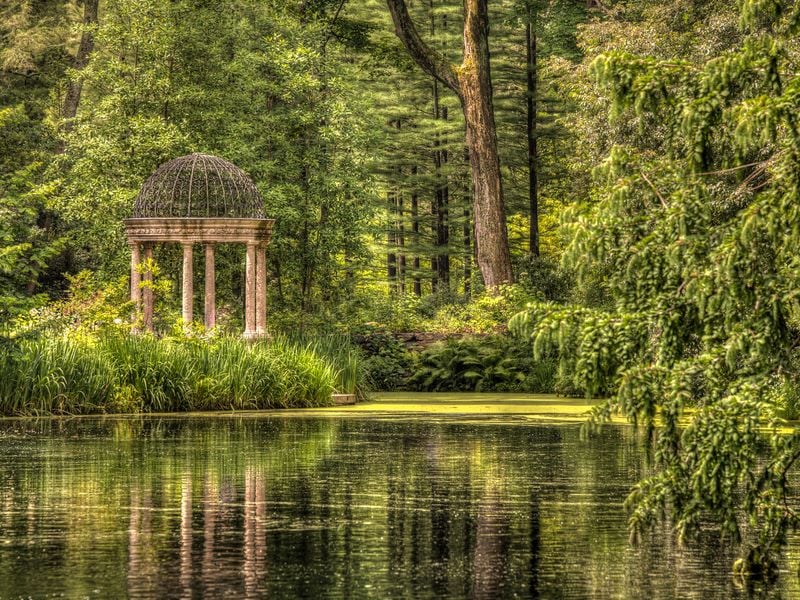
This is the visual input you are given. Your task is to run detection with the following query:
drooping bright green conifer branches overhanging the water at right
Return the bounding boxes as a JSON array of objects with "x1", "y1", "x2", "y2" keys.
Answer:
[{"x1": 510, "y1": 1, "x2": 800, "y2": 574}]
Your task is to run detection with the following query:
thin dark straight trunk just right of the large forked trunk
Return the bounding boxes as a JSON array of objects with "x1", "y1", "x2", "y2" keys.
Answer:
[{"x1": 525, "y1": 16, "x2": 539, "y2": 256}]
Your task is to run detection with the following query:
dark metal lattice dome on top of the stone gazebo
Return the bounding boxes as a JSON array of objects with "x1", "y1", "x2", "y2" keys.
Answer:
[{"x1": 133, "y1": 153, "x2": 265, "y2": 219}]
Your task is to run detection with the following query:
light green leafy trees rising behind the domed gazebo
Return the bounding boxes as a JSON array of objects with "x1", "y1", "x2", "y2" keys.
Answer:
[{"x1": 0, "y1": 0, "x2": 374, "y2": 314}]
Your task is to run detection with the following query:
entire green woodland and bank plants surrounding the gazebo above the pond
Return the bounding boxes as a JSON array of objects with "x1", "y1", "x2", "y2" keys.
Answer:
[{"x1": 0, "y1": 0, "x2": 800, "y2": 578}]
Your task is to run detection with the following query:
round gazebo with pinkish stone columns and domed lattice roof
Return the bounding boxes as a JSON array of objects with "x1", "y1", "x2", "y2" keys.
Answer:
[{"x1": 124, "y1": 154, "x2": 274, "y2": 337}]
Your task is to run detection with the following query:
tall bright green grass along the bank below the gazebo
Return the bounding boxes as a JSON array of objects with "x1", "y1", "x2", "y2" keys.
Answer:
[{"x1": 0, "y1": 335, "x2": 363, "y2": 415}]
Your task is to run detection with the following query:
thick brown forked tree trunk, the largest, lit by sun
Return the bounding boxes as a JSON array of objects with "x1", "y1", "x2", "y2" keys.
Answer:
[{"x1": 387, "y1": 0, "x2": 513, "y2": 289}]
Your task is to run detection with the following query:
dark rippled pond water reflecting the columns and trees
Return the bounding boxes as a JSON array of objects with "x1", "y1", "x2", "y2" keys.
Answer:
[{"x1": 0, "y1": 396, "x2": 800, "y2": 598}]
